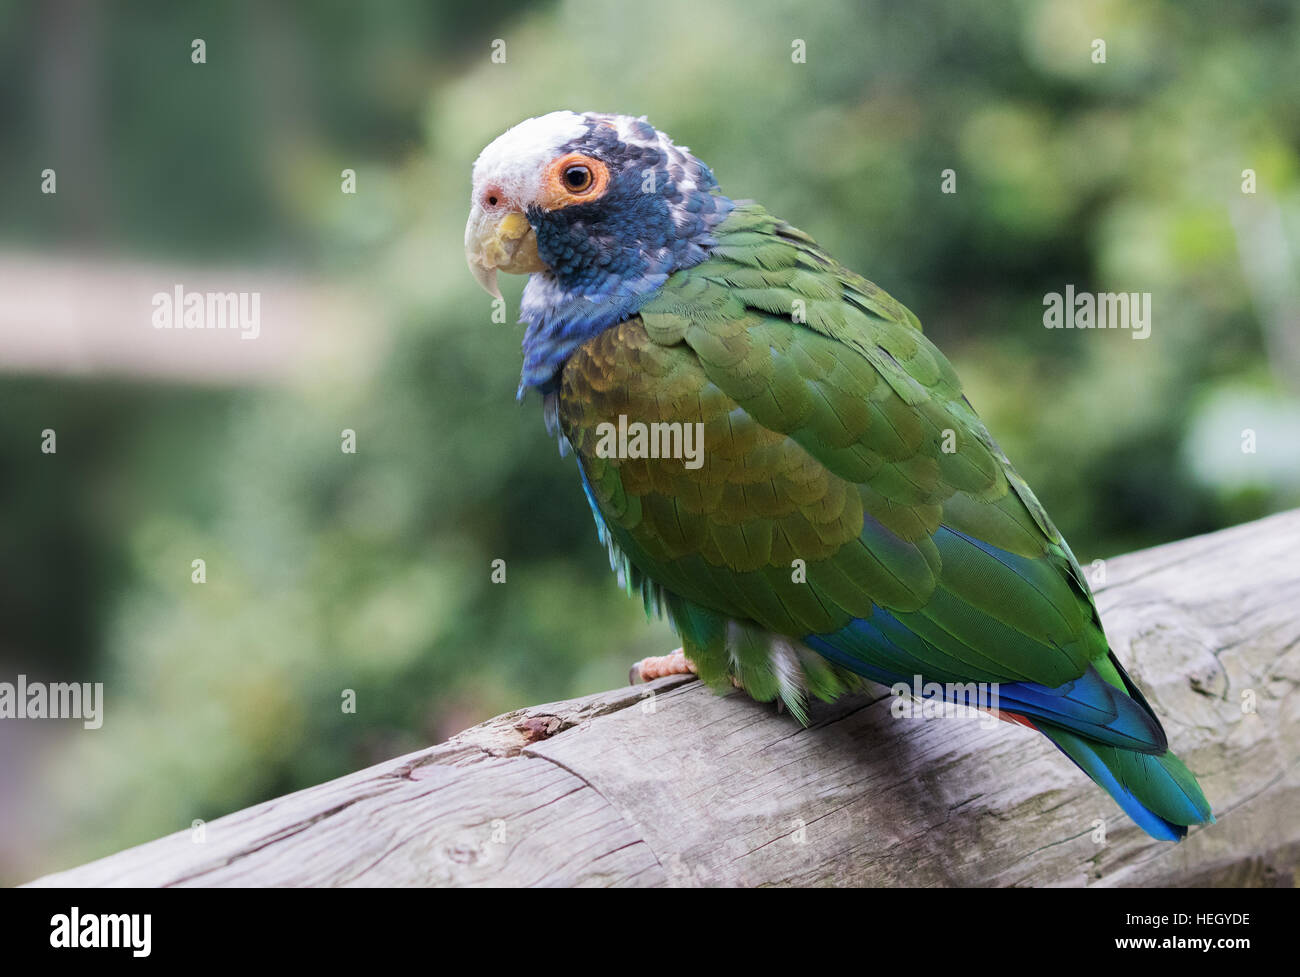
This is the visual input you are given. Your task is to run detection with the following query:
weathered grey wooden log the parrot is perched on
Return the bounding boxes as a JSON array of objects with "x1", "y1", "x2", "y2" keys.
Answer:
[{"x1": 22, "y1": 512, "x2": 1300, "y2": 886}]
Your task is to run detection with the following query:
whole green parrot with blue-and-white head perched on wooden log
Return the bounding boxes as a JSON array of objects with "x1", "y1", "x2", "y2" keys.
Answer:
[{"x1": 464, "y1": 110, "x2": 1214, "y2": 841}]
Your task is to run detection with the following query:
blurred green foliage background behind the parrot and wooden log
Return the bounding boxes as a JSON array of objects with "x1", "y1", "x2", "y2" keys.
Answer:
[{"x1": 0, "y1": 0, "x2": 1300, "y2": 882}]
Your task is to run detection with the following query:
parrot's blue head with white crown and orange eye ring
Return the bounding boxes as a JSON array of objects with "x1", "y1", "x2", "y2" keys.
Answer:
[{"x1": 465, "y1": 112, "x2": 733, "y2": 387}]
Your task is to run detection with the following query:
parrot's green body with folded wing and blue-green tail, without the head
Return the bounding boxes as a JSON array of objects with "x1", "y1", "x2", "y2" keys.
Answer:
[{"x1": 556, "y1": 205, "x2": 1212, "y2": 837}]
